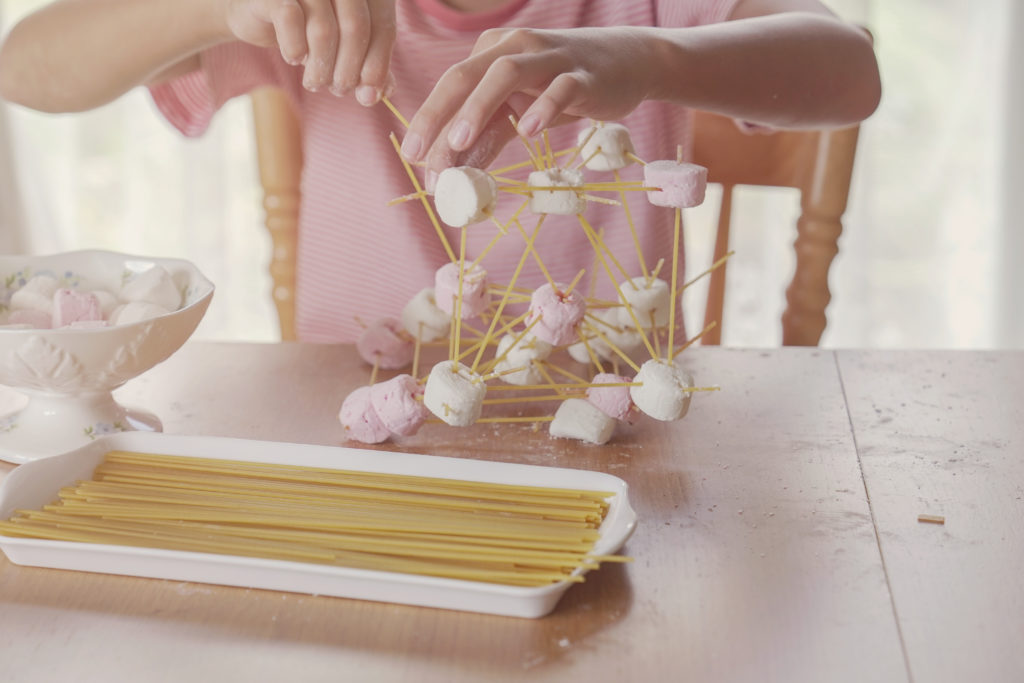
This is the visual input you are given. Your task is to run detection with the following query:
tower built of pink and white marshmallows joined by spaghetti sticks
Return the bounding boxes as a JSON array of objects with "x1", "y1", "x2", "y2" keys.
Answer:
[{"x1": 339, "y1": 100, "x2": 725, "y2": 443}]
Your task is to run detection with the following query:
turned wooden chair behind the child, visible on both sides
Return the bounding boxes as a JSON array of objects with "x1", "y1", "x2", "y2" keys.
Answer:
[{"x1": 252, "y1": 89, "x2": 858, "y2": 346}]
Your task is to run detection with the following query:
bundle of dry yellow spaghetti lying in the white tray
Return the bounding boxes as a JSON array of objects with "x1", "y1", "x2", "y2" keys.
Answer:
[{"x1": 0, "y1": 452, "x2": 629, "y2": 586}]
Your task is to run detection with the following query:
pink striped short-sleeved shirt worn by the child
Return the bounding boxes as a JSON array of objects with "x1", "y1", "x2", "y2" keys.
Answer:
[{"x1": 153, "y1": 0, "x2": 737, "y2": 342}]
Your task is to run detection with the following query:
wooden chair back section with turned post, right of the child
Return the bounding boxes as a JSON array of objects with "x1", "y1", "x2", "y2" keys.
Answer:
[{"x1": 693, "y1": 112, "x2": 859, "y2": 346}]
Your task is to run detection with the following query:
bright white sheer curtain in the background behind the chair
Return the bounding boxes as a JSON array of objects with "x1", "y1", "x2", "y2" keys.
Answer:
[{"x1": 0, "y1": 0, "x2": 1024, "y2": 348}]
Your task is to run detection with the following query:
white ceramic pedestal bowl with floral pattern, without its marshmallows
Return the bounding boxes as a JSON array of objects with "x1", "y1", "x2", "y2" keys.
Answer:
[{"x1": 0, "y1": 251, "x2": 213, "y2": 463}]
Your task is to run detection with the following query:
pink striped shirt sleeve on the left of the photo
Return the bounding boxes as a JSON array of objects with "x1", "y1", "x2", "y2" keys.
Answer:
[{"x1": 150, "y1": 42, "x2": 299, "y2": 137}]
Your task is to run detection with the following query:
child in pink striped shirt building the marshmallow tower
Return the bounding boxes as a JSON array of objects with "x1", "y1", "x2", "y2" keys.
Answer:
[{"x1": 0, "y1": 0, "x2": 880, "y2": 341}]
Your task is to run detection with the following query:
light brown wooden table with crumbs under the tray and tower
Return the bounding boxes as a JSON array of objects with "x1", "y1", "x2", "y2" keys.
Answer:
[{"x1": 0, "y1": 342, "x2": 1024, "y2": 683}]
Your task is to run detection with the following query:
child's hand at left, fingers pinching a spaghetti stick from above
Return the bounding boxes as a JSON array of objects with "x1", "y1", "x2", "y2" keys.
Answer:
[{"x1": 226, "y1": 0, "x2": 395, "y2": 105}]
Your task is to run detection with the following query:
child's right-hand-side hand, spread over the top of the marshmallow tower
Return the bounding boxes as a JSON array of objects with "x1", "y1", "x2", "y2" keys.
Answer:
[{"x1": 401, "y1": 28, "x2": 658, "y2": 172}]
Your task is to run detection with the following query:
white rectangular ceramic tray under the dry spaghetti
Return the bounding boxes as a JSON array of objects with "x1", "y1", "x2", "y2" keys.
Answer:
[{"x1": 0, "y1": 432, "x2": 636, "y2": 617}]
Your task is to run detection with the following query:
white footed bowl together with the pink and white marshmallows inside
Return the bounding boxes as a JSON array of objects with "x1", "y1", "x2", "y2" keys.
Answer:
[{"x1": 0, "y1": 251, "x2": 214, "y2": 463}]
